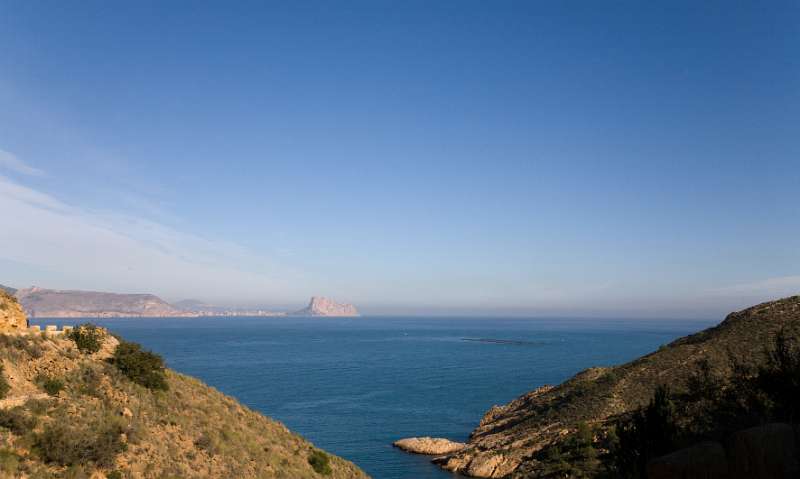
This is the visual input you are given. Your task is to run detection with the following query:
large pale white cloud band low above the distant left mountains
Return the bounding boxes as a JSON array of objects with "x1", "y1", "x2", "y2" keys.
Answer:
[{"x1": 0, "y1": 176, "x2": 308, "y2": 304}]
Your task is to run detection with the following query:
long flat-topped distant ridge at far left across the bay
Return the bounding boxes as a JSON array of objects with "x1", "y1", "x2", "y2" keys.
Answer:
[{"x1": 16, "y1": 287, "x2": 193, "y2": 318}]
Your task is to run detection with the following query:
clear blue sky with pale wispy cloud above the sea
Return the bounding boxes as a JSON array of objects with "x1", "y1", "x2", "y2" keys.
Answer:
[{"x1": 0, "y1": 0, "x2": 800, "y2": 318}]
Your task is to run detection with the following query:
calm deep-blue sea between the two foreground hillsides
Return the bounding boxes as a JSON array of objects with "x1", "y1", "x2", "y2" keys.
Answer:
[{"x1": 34, "y1": 317, "x2": 709, "y2": 479}]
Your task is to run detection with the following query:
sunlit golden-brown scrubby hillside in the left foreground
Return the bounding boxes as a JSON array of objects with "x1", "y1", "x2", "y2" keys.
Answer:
[{"x1": 0, "y1": 296, "x2": 367, "y2": 479}]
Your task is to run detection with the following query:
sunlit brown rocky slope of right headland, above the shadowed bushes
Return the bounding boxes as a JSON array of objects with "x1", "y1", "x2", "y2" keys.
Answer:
[{"x1": 416, "y1": 296, "x2": 800, "y2": 478}]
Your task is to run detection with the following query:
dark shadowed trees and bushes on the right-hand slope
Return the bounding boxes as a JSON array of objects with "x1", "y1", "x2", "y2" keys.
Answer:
[{"x1": 605, "y1": 331, "x2": 800, "y2": 479}]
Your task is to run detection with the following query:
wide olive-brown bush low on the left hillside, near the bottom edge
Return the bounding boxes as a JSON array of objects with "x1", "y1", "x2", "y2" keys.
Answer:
[{"x1": 36, "y1": 414, "x2": 125, "y2": 467}]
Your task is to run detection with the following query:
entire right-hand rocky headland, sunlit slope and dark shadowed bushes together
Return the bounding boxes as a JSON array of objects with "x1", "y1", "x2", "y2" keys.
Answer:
[{"x1": 398, "y1": 296, "x2": 800, "y2": 479}]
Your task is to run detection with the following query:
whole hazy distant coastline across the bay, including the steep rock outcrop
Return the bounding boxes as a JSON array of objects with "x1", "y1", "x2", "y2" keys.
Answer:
[{"x1": 0, "y1": 285, "x2": 359, "y2": 318}]
